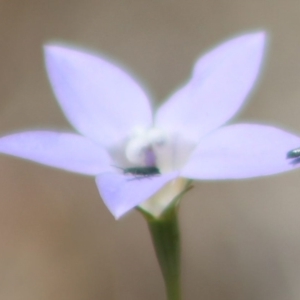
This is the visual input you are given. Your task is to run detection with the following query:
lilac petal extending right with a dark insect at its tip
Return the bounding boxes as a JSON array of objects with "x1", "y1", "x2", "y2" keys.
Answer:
[{"x1": 181, "y1": 124, "x2": 300, "y2": 180}]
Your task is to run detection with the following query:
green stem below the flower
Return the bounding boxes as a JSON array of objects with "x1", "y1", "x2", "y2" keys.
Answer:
[{"x1": 148, "y1": 210, "x2": 181, "y2": 300}]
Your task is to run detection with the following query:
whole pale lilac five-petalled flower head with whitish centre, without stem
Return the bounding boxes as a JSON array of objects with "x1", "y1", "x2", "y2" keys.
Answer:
[{"x1": 0, "y1": 32, "x2": 300, "y2": 218}]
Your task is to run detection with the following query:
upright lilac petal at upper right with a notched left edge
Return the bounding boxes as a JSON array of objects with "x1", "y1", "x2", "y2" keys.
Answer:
[{"x1": 156, "y1": 32, "x2": 266, "y2": 141}]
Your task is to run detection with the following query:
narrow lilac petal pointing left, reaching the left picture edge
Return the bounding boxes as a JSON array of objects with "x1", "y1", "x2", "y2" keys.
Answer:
[{"x1": 0, "y1": 131, "x2": 112, "y2": 175}]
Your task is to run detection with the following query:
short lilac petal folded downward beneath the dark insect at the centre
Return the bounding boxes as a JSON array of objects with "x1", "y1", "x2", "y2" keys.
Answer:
[{"x1": 96, "y1": 172, "x2": 178, "y2": 219}]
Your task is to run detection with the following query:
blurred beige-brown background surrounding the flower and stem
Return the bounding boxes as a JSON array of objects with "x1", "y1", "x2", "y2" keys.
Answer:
[{"x1": 0, "y1": 0, "x2": 300, "y2": 300}]
